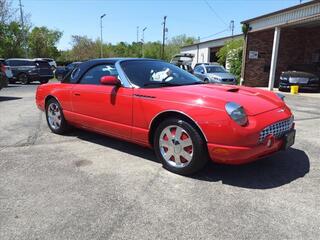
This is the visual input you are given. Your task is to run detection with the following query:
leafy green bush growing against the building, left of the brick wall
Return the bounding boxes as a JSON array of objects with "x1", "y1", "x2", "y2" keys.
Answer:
[{"x1": 217, "y1": 38, "x2": 244, "y2": 81}]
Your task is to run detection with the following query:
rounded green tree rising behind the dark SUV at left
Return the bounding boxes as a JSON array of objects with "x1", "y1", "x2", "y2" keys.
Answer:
[{"x1": 28, "y1": 27, "x2": 62, "y2": 58}]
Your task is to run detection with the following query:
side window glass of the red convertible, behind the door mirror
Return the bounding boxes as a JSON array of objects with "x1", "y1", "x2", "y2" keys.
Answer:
[{"x1": 80, "y1": 64, "x2": 118, "y2": 85}]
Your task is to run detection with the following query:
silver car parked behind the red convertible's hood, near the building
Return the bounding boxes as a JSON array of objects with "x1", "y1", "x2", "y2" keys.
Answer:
[{"x1": 194, "y1": 64, "x2": 237, "y2": 85}]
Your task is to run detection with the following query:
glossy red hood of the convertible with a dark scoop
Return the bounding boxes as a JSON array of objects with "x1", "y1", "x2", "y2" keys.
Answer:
[{"x1": 140, "y1": 84, "x2": 284, "y2": 116}]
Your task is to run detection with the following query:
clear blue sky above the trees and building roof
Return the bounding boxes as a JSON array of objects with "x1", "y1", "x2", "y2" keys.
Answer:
[{"x1": 13, "y1": 0, "x2": 306, "y2": 50}]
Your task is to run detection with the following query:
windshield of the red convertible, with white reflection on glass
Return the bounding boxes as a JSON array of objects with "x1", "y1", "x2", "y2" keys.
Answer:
[{"x1": 121, "y1": 60, "x2": 203, "y2": 87}]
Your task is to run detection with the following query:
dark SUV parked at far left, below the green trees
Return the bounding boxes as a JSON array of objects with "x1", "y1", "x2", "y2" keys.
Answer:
[{"x1": 6, "y1": 58, "x2": 53, "y2": 84}]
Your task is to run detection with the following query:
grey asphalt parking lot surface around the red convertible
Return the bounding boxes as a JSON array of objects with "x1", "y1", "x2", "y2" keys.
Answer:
[{"x1": 0, "y1": 85, "x2": 320, "y2": 240}]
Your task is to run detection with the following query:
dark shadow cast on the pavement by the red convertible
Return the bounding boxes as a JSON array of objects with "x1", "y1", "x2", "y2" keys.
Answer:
[{"x1": 70, "y1": 129, "x2": 310, "y2": 189}]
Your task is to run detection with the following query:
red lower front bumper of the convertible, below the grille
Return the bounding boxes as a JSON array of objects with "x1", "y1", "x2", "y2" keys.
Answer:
[{"x1": 207, "y1": 139, "x2": 284, "y2": 165}]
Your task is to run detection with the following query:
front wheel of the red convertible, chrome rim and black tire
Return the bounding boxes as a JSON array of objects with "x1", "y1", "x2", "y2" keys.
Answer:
[{"x1": 154, "y1": 118, "x2": 208, "y2": 175}]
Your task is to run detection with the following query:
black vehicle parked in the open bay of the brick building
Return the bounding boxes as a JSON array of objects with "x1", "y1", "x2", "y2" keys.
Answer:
[{"x1": 279, "y1": 64, "x2": 320, "y2": 91}]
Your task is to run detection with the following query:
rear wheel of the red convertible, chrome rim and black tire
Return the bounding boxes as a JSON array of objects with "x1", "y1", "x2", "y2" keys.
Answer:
[{"x1": 46, "y1": 98, "x2": 69, "y2": 134}]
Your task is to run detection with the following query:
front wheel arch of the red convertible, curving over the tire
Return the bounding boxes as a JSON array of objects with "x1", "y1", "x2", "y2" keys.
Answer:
[{"x1": 149, "y1": 110, "x2": 208, "y2": 146}]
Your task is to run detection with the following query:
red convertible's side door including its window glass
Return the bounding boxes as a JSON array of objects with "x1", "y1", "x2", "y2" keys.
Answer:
[{"x1": 71, "y1": 64, "x2": 133, "y2": 138}]
